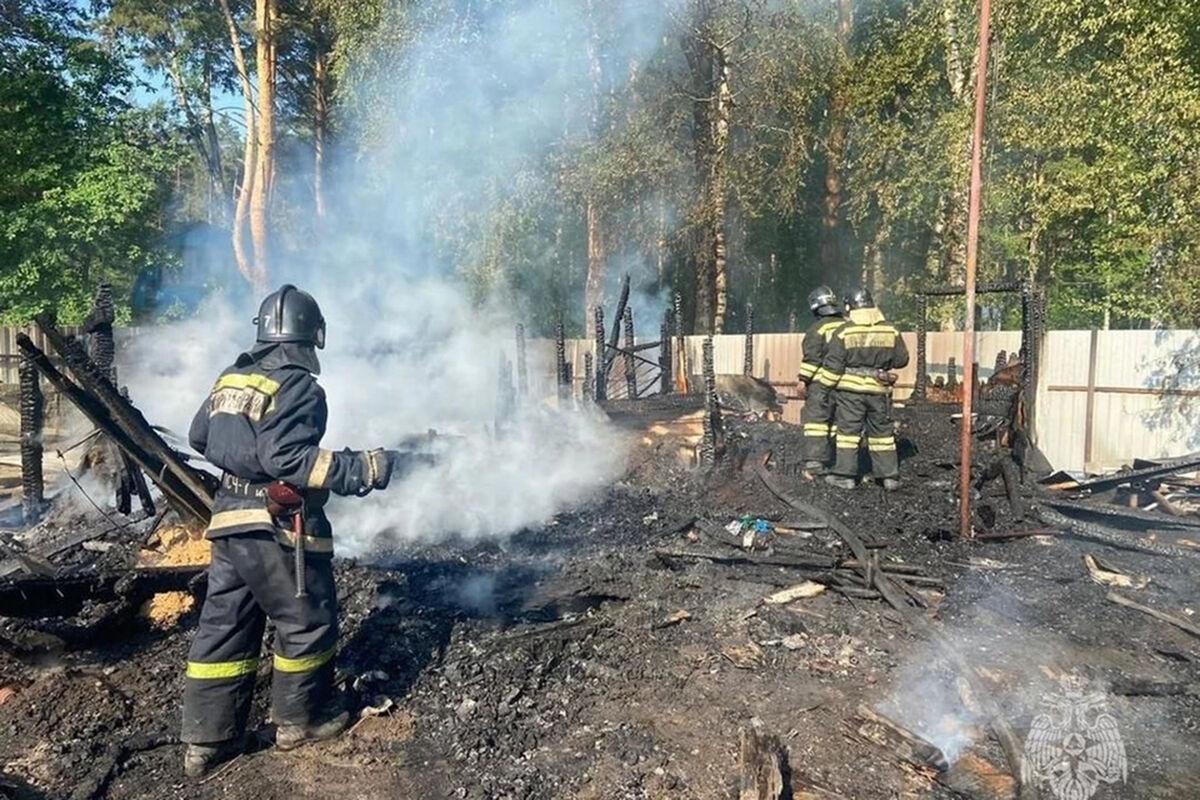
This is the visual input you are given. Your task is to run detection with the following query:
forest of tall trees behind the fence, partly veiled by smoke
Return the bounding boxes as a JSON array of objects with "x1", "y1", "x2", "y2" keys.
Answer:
[{"x1": 0, "y1": 0, "x2": 1200, "y2": 333}]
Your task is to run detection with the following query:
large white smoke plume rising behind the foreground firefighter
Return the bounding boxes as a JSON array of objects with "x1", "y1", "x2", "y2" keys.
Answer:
[{"x1": 122, "y1": 0, "x2": 686, "y2": 555}]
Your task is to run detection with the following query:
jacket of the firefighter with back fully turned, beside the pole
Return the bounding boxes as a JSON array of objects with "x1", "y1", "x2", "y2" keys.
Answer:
[{"x1": 823, "y1": 308, "x2": 908, "y2": 395}]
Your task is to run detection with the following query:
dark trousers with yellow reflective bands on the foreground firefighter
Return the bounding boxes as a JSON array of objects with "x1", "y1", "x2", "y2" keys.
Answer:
[{"x1": 181, "y1": 531, "x2": 337, "y2": 744}]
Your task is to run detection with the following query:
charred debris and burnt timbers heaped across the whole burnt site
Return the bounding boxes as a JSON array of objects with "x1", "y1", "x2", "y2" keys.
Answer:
[{"x1": 0, "y1": 289, "x2": 1200, "y2": 800}]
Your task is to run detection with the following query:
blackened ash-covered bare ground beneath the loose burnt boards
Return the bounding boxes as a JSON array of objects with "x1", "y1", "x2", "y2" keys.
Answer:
[{"x1": 0, "y1": 409, "x2": 1200, "y2": 800}]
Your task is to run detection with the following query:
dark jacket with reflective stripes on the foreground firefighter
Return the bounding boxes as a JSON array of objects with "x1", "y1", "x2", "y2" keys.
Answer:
[{"x1": 188, "y1": 344, "x2": 371, "y2": 553}]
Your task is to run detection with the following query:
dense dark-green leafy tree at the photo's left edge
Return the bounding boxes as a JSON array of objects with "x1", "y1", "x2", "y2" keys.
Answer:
[{"x1": 0, "y1": 6, "x2": 178, "y2": 321}]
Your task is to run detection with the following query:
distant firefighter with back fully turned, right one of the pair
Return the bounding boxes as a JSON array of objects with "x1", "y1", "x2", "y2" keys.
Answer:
[{"x1": 824, "y1": 289, "x2": 908, "y2": 491}]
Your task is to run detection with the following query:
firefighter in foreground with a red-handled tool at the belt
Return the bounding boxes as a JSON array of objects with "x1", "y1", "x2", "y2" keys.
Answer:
[{"x1": 175, "y1": 285, "x2": 424, "y2": 777}]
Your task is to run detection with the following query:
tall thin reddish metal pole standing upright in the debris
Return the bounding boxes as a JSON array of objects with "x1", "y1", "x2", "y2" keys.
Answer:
[{"x1": 959, "y1": 0, "x2": 991, "y2": 539}]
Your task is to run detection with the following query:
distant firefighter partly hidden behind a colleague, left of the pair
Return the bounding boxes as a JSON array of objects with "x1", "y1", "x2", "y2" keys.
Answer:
[{"x1": 799, "y1": 285, "x2": 846, "y2": 474}]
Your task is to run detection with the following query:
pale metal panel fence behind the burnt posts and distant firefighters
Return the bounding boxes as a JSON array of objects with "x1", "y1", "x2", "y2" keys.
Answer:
[{"x1": 559, "y1": 331, "x2": 1200, "y2": 473}]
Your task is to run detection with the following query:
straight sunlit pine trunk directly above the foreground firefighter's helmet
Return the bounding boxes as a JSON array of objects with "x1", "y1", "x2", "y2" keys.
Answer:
[{"x1": 250, "y1": 0, "x2": 280, "y2": 293}]
